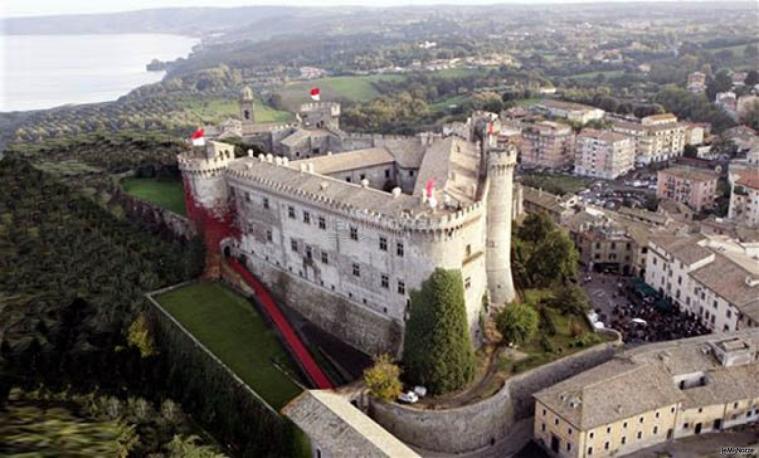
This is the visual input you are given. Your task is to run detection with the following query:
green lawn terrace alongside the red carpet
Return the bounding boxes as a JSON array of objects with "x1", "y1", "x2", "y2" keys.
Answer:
[{"x1": 156, "y1": 283, "x2": 301, "y2": 410}]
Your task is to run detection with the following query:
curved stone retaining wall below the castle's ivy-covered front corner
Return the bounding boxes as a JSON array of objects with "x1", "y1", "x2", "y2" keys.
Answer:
[{"x1": 369, "y1": 342, "x2": 620, "y2": 454}]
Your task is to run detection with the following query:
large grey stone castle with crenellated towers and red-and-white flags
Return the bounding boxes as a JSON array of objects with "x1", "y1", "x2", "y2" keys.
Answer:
[{"x1": 178, "y1": 90, "x2": 516, "y2": 354}]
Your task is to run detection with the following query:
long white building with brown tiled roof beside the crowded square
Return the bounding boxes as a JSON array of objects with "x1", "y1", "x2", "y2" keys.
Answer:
[{"x1": 645, "y1": 234, "x2": 759, "y2": 332}]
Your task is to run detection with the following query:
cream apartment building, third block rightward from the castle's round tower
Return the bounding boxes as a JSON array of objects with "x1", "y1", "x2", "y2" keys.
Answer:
[{"x1": 612, "y1": 114, "x2": 686, "y2": 165}]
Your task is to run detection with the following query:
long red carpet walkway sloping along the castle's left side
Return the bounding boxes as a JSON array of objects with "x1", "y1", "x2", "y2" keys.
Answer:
[{"x1": 228, "y1": 258, "x2": 334, "y2": 389}]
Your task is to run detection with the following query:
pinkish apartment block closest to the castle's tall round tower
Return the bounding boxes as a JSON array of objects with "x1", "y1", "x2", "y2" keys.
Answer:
[{"x1": 519, "y1": 121, "x2": 575, "y2": 169}]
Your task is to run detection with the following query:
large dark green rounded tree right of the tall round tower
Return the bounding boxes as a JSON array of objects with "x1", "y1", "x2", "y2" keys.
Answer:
[{"x1": 527, "y1": 229, "x2": 580, "y2": 287}]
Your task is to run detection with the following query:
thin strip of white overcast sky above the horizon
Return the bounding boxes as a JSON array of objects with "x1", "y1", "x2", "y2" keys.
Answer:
[{"x1": 0, "y1": 0, "x2": 712, "y2": 17}]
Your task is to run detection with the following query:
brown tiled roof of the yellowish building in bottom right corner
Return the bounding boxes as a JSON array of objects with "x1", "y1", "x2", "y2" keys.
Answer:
[{"x1": 535, "y1": 328, "x2": 759, "y2": 431}]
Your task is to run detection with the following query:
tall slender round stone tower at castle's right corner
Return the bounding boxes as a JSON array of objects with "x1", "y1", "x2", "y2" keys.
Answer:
[{"x1": 485, "y1": 144, "x2": 517, "y2": 306}]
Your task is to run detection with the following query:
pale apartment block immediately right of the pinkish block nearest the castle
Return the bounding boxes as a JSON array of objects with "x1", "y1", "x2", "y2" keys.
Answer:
[{"x1": 574, "y1": 129, "x2": 635, "y2": 180}]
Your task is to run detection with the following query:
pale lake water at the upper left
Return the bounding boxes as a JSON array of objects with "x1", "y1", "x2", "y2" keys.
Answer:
[{"x1": 0, "y1": 34, "x2": 198, "y2": 111}]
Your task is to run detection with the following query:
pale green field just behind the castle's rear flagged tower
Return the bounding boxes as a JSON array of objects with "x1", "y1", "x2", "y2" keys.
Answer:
[{"x1": 278, "y1": 75, "x2": 404, "y2": 110}]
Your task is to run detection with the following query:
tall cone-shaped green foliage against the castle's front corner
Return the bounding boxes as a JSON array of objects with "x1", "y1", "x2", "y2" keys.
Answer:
[{"x1": 403, "y1": 268, "x2": 475, "y2": 394}]
